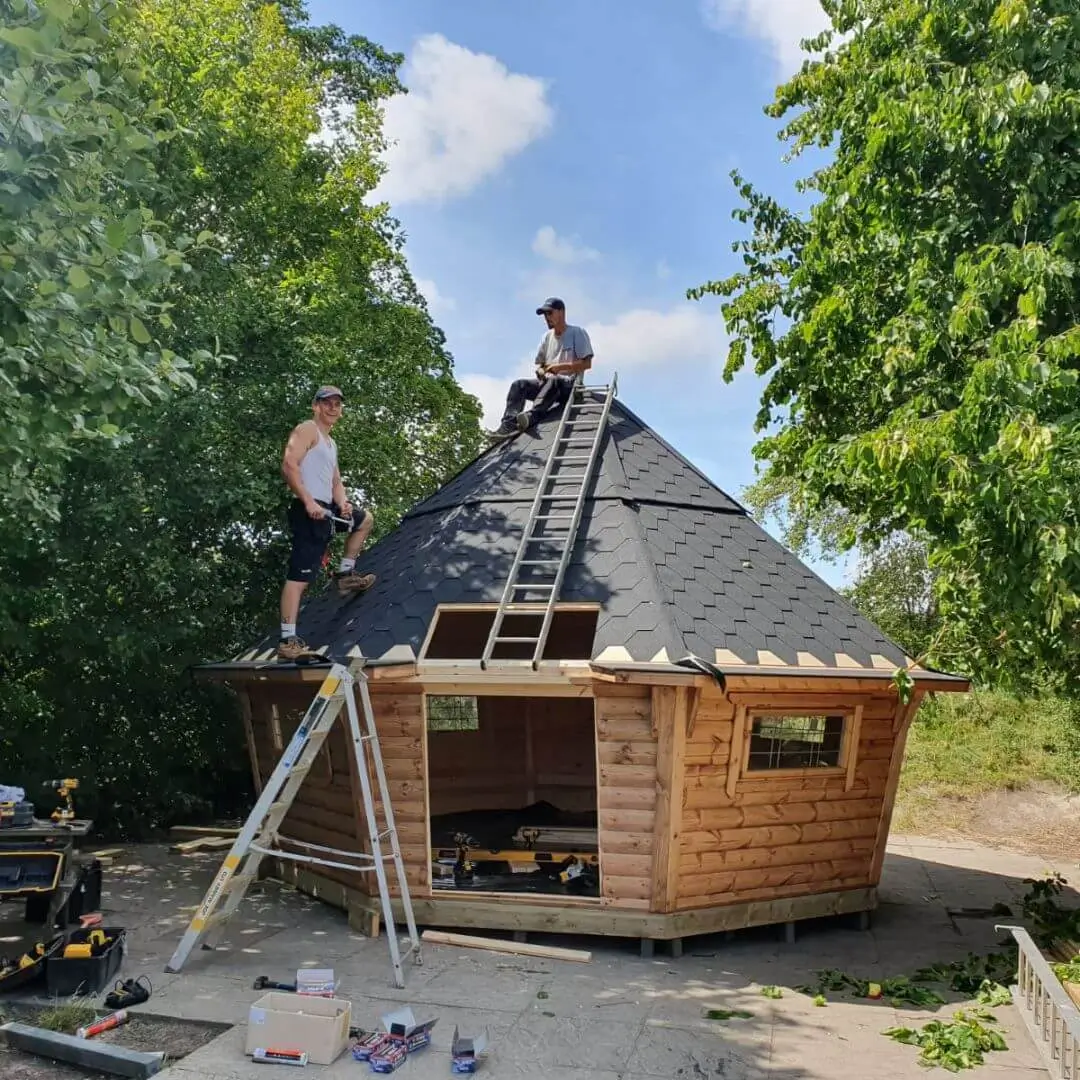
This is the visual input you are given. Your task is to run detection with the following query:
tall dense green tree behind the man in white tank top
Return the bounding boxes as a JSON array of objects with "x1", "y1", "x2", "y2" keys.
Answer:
[{"x1": 0, "y1": 0, "x2": 481, "y2": 833}]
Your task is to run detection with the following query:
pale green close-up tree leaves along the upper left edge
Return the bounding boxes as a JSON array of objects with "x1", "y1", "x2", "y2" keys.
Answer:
[{"x1": 0, "y1": 0, "x2": 210, "y2": 529}]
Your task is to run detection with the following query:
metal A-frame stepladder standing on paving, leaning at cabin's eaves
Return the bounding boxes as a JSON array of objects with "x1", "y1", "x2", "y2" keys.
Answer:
[{"x1": 165, "y1": 660, "x2": 422, "y2": 988}]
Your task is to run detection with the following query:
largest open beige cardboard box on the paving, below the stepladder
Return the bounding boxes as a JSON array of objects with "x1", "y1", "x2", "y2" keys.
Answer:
[{"x1": 245, "y1": 991, "x2": 352, "y2": 1065}]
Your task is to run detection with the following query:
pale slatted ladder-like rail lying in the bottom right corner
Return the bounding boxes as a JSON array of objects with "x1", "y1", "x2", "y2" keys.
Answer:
[{"x1": 996, "y1": 926, "x2": 1080, "y2": 1080}]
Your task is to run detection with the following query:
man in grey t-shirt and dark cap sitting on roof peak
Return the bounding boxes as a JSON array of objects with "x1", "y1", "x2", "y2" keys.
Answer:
[{"x1": 488, "y1": 296, "x2": 593, "y2": 440}]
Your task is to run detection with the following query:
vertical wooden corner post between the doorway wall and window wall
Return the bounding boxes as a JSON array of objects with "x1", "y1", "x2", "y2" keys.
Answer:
[{"x1": 650, "y1": 687, "x2": 690, "y2": 912}]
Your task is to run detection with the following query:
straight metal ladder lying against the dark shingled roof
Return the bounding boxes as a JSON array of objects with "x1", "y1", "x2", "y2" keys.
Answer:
[{"x1": 481, "y1": 375, "x2": 619, "y2": 669}]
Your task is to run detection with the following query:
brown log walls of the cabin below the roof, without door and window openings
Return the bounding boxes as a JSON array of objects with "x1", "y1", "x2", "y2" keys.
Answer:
[{"x1": 212, "y1": 662, "x2": 946, "y2": 950}]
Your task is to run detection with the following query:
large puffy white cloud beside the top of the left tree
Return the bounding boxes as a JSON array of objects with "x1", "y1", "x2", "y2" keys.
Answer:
[{"x1": 375, "y1": 33, "x2": 554, "y2": 203}]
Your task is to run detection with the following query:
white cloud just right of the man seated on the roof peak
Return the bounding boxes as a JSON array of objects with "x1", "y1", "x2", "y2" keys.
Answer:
[{"x1": 585, "y1": 305, "x2": 726, "y2": 372}]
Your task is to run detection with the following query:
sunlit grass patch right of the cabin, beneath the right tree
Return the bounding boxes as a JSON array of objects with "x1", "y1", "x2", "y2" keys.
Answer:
[{"x1": 894, "y1": 690, "x2": 1080, "y2": 833}]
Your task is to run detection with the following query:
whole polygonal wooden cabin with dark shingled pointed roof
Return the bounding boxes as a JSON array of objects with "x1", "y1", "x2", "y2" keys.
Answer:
[{"x1": 202, "y1": 388, "x2": 968, "y2": 950}]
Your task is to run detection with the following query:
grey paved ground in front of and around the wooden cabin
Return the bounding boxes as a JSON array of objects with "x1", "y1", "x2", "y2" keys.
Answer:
[{"x1": 0, "y1": 838, "x2": 1077, "y2": 1080}]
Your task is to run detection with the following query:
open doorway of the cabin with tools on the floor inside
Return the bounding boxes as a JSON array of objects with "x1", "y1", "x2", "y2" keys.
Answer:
[{"x1": 426, "y1": 694, "x2": 600, "y2": 897}]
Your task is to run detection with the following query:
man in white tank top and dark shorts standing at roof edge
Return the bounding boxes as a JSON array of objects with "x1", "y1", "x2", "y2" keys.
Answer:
[{"x1": 278, "y1": 387, "x2": 375, "y2": 660}]
